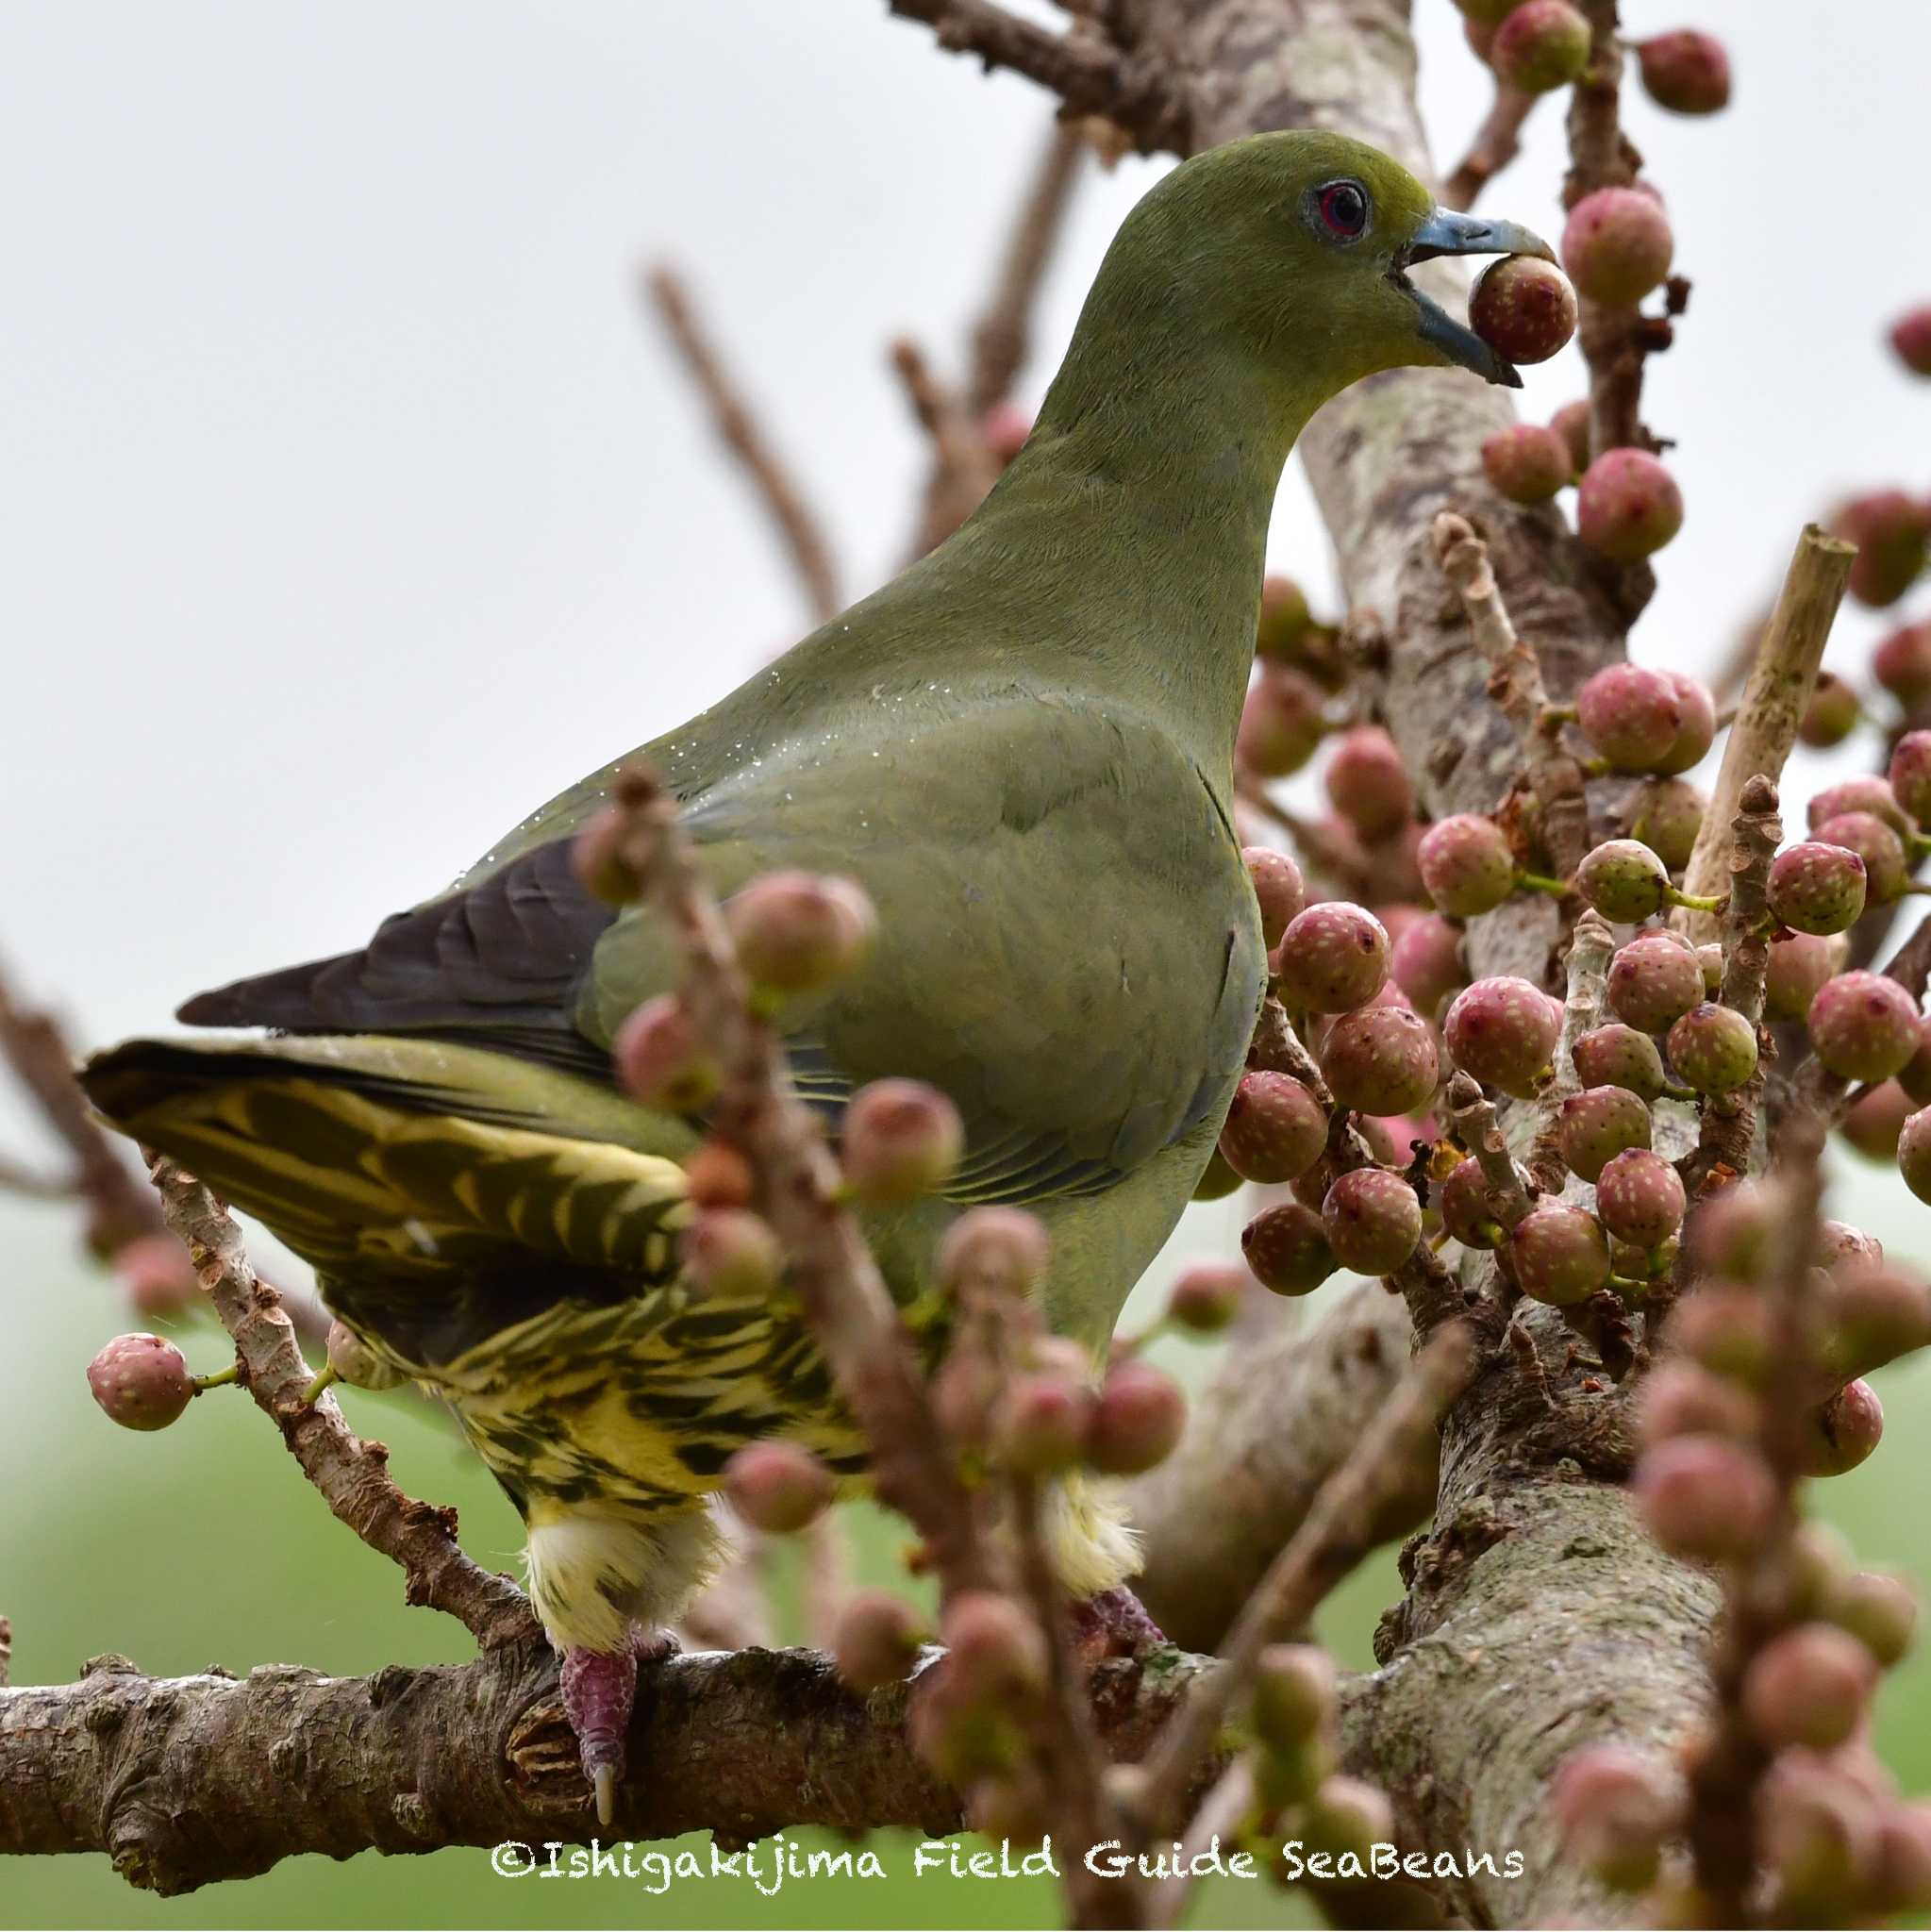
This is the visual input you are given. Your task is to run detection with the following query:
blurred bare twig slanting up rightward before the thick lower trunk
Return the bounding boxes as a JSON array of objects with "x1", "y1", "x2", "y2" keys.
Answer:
[{"x1": 1145, "y1": 1325, "x2": 1473, "y2": 1836}]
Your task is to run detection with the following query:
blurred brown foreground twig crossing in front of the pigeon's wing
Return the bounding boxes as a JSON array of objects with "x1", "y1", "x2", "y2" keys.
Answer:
[{"x1": 612, "y1": 765, "x2": 994, "y2": 1592}]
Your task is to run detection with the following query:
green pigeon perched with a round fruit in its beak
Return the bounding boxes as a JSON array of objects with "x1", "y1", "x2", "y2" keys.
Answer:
[{"x1": 85, "y1": 131, "x2": 1553, "y2": 1810}]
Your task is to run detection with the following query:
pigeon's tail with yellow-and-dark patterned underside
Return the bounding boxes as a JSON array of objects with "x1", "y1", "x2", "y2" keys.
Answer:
[{"x1": 81, "y1": 1036, "x2": 691, "y2": 1279}]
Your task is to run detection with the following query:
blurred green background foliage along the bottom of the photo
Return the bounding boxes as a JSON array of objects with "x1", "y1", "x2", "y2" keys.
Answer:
[{"x1": 0, "y1": 1169, "x2": 1931, "y2": 1928}]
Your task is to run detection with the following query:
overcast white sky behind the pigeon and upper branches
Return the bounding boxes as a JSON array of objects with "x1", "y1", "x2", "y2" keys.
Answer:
[{"x1": 0, "y1": 11, "x2": 1931, "y2": 1282}]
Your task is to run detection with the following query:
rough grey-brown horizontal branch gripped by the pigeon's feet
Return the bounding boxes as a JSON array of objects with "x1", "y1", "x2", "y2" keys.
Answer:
[{"x1": 0, "y1": 1644, "x2": 1210, "y2": 1893}]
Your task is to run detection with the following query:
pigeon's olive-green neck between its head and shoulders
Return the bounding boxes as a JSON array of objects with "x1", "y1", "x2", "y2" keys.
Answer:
[{"x1": 929, "y1": 330, "x2": 1321, "y2": 802}]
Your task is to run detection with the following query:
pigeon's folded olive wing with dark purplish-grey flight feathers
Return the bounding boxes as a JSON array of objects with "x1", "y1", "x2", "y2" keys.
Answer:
[{"x1": 181, "y1": 693, "x2": 1261, "y2": 1202}]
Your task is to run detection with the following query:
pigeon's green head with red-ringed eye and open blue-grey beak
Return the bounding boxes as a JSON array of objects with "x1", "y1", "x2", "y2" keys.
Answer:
[{"x1": 1057, "y1": 129, "x2": 1555, "y2": 426}]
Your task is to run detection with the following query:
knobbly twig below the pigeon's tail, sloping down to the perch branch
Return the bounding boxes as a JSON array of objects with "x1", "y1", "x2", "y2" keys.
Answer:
[{"x1": 153, "y1": 1156, "x2": 539, "y2": 1650}]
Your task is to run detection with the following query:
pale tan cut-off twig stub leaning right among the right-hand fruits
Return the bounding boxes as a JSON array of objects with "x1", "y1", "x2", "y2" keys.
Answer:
[{"x1": 1674, "y1": 524, "x2": 1857, "y2": 944}]
